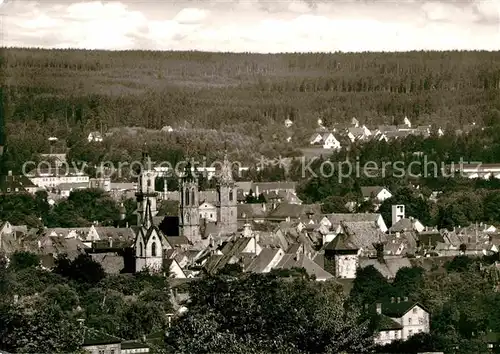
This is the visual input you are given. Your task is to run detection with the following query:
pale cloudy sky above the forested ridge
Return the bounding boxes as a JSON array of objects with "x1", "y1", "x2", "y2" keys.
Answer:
[{"x1": 0, "y1": 0, "x2": 500, "y2": 53}]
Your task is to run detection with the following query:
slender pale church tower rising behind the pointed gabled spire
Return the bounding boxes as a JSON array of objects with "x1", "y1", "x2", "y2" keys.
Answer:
[{"x1": 135, "y1": 152, "x2": 158, "y2": 225}]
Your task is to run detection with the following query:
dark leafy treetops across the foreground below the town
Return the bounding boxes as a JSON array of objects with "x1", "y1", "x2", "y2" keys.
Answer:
[{"x1": 0, "y1": 252, "x2": 500, "y2": 354}]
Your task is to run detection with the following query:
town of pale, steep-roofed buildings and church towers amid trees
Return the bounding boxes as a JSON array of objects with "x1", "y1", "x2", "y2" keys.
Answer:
[{"x1": 0, "y1": 110, "x2": 500, "y2": 353}]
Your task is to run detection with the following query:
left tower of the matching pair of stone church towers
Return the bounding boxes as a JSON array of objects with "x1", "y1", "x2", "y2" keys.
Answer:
[{"x1": 179, "y1": 163, "x2": 201, "y2": 243}]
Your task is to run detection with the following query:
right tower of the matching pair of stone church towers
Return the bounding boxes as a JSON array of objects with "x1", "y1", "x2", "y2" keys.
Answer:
[{"x1": 217, "y1": 152, "x2": 238, "y2": 234}]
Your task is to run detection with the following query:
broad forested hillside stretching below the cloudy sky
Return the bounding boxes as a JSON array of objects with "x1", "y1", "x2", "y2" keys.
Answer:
[{"x1": 2, "y1": 49, "x2": 500, "y2": 167}]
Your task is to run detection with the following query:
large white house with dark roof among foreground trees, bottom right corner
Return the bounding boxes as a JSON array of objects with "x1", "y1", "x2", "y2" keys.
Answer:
[{"x1": 375, "y1": 297, "x2": 430, "y2": 344}]
